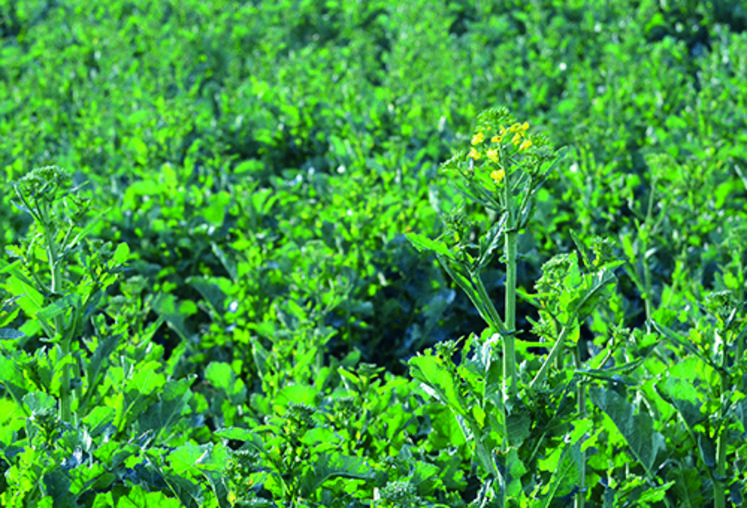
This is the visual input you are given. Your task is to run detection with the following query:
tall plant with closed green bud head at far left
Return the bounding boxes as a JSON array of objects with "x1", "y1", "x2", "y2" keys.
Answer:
[{"x1": 0, "y1": 166, "x2": 129, "y2": 422}]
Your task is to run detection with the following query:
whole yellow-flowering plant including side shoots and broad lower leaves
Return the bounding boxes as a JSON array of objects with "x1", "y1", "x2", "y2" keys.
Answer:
[{"x1": 409, "y1": 108, "x2": 632, "y2": 506}]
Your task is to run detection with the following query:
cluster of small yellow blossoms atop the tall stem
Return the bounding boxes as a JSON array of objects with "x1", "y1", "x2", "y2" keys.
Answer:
[{"x1": 467, "y1": 122, "x2": 532, "y2": 185}]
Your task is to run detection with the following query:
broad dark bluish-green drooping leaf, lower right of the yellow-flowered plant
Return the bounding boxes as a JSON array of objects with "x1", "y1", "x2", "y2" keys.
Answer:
[{"x1": 589, "y1": 386, "x2": 666, "y2": 478}]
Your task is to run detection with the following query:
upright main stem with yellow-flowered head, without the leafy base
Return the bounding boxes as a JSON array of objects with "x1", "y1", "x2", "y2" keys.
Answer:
[{"x1": 444, "y1": 108, "x2": 559, "y2": 400}]
